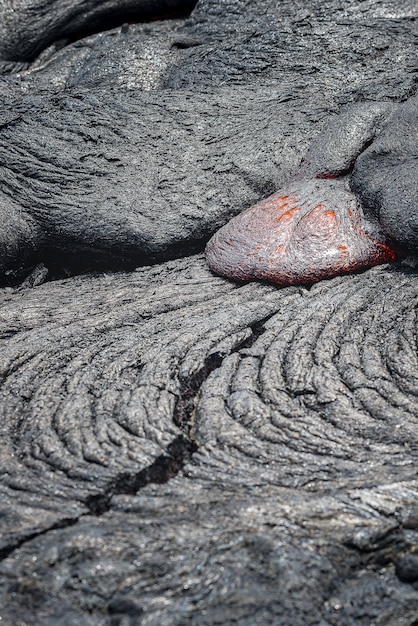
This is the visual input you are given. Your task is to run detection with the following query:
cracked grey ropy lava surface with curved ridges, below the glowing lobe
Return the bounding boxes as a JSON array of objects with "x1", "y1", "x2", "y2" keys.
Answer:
[{"x1": 0, "y1": 256, "x2": 418, "y2": 626}]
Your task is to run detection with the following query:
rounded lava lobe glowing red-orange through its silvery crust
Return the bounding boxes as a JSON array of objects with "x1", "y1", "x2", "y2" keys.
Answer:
[{"x1": 206, "y1": 177, "x2": 395, "y2": 285}]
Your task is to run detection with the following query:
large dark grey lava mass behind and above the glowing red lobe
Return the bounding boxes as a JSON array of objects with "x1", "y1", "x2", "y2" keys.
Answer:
[{"x1": 0, "y1": 0, "x2": 417, "y2": 281}]
